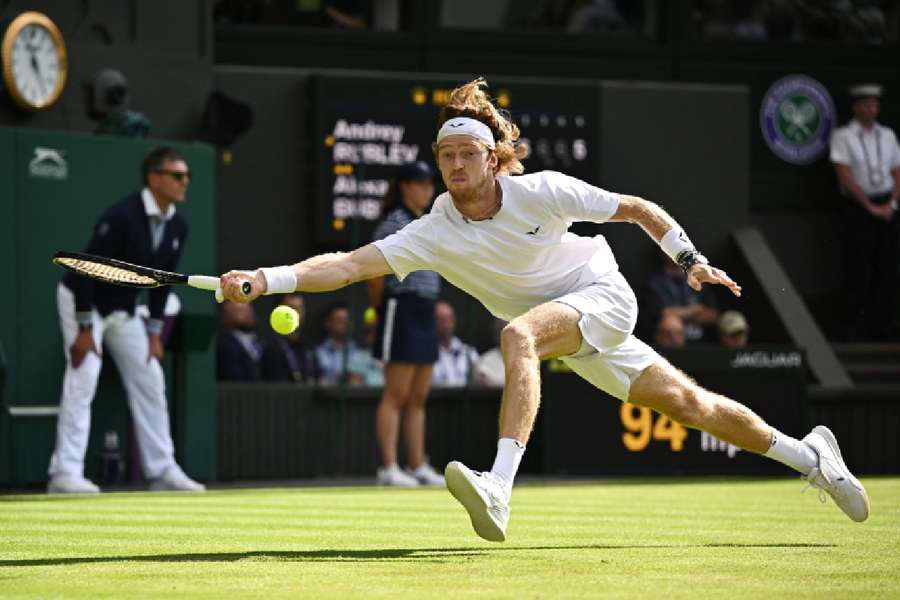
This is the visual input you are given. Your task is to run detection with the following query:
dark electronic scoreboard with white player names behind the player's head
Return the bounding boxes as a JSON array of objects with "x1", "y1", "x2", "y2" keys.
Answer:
[{"x1": 313, "y1": 74, "x2": 597, "y2": 248}]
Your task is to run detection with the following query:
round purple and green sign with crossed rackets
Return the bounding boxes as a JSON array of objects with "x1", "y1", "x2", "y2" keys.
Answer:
[{"x1": 759, "y1": 75, "x2": 835, "y2": 165}]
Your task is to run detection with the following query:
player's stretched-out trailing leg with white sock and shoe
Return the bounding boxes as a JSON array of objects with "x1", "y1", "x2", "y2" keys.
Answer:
[{"x1": 628, "y1": 360, "x2": 869, "y2": 521}]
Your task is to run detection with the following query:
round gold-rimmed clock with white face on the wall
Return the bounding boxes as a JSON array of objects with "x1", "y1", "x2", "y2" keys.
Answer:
[{"x1": 2, "y1": 12, "x2": 66, "y2": 110}]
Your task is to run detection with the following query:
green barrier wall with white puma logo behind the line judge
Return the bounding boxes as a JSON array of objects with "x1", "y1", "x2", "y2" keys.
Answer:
[{"x1": 0, "y1": 128, "x2": 216, "y2": 487}]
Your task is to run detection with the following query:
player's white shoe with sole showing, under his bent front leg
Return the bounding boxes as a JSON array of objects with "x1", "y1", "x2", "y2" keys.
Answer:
[{"x1": 444, "y1": 461, "x2": 509, "y2": 542}]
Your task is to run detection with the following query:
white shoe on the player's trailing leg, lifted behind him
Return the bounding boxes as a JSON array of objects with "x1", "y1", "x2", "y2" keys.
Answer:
[{"x1": 801, "y1": 425, "x2": 869, "y2": 522}]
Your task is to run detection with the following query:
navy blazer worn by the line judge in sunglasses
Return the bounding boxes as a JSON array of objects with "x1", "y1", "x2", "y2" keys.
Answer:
[{"x1": 63, "y1": 192, "x2": 187, "y2": 319}]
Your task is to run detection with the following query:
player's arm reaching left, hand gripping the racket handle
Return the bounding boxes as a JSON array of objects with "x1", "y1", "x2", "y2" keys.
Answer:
[{"x1": 221, "y1": 244, "x2": 391, "y2": 302}]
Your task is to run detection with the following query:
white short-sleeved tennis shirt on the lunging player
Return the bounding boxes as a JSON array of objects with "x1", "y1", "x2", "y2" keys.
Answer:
[{"x1": 373, "y1": 171, "x2": 619, "y2": 320}]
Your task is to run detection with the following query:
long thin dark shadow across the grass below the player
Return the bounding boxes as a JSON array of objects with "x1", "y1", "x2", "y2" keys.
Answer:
[{"x1": 0, "y1": 543, "x2": 835, "y2": 569}]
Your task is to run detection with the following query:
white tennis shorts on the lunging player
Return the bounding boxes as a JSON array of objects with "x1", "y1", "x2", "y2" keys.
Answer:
[{"x1": 554, "y1": 271, "x2": 661, "y2": 402}]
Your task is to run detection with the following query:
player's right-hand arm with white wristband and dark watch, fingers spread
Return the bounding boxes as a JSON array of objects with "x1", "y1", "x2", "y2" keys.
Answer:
[{"x1": 610, "y1": 196, "x2": 741, "y2": 296}]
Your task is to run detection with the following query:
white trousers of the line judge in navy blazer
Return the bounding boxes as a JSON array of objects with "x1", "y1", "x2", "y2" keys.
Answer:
[{"x1": 49, "y1": 284, "x2": 175, "y2": 479}]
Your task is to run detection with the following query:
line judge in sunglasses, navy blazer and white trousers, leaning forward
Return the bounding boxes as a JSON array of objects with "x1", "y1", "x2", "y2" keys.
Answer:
[{"x1": 47, "y1": 147, "x2": 205, "y2": 493}]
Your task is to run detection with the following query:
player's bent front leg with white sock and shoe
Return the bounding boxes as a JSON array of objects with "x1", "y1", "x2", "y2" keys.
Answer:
[{"x1": 445, "y1": 302, "x2": 582, "y2": 542}]
